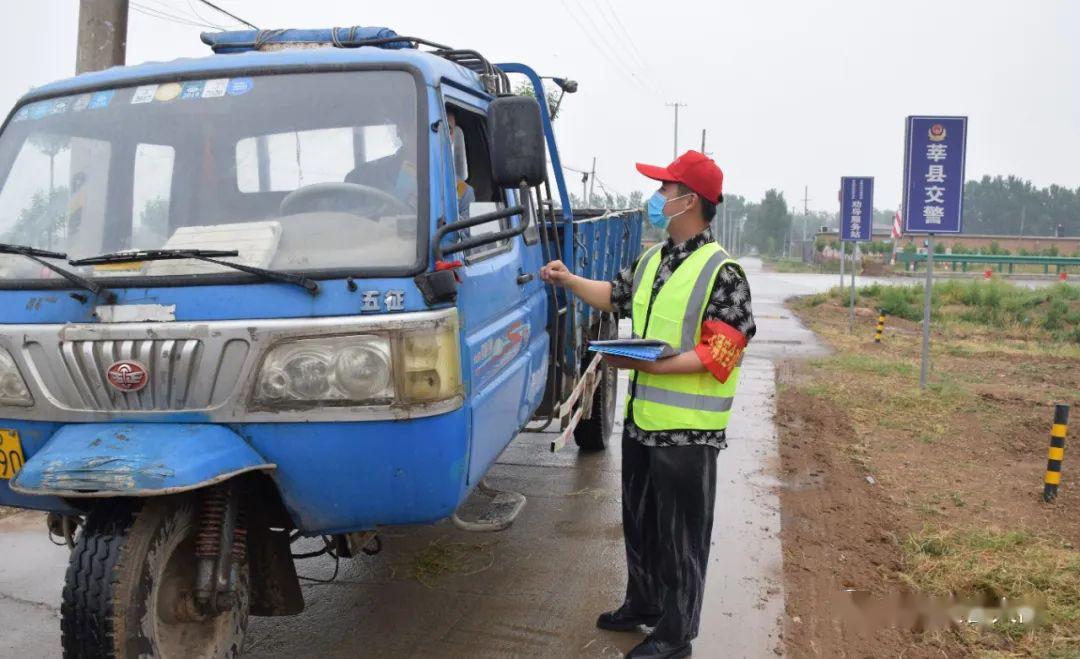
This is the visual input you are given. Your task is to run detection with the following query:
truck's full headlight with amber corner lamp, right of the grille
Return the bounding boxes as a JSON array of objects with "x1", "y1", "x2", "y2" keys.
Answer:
[{"x1": 253, "y1": 313, "x2": 461, "y2": 407}]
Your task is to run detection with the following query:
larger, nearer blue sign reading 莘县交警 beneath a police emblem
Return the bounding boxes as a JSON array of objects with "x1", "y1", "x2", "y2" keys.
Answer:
[{"x1": 903, "y1": 117, "x2": 968, "y2": 233}]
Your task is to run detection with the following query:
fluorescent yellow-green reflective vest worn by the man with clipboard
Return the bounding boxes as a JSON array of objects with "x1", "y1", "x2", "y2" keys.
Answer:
[{"x1": 627, "y1": 242, "x2": 741, "y2": 430}]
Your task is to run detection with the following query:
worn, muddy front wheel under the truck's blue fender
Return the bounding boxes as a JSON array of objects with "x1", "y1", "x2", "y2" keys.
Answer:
[{"x1": 60, "y1": 497, "x2": 251, "y2": 659}]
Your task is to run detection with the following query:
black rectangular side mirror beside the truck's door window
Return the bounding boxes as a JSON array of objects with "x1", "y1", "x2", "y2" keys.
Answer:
[{"x1": 487, "y1": 96, "x2": 548, "y2": 188}]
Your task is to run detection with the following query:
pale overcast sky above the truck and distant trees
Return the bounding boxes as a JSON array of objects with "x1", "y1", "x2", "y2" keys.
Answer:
[{"x1": 0, "y1": 0, "x2": 1080, "y2": 212}]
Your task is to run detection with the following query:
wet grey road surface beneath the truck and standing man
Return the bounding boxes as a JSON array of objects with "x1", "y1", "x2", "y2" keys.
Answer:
[{"x1": 0, "y1": 259, "x2": 863, "y2": 659}]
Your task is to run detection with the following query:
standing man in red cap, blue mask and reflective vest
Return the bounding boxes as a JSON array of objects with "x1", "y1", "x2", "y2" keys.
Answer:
[{"x1": 540, "y1": 151, "x2": 756, "y2": 659}]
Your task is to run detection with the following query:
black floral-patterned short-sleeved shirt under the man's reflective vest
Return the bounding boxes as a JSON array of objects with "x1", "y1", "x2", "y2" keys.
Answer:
[{"x1": 611, "y1": 229, "x2": 757, "y2": 448}]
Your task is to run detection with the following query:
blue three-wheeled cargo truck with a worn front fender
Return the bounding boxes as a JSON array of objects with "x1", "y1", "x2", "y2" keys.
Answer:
[{"x1": 0, "y1": 28, "x2": 642, "y2": 657}]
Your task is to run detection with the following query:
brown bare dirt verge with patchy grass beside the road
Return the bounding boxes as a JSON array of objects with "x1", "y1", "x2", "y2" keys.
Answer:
[{"x1": 777, "y1": 299, "x2": 1080, "y2": 658}]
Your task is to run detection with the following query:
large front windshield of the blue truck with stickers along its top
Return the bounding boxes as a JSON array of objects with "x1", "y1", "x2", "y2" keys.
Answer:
[{"x1": 0, "y1": 71, "x2": 424, "y2": 282}]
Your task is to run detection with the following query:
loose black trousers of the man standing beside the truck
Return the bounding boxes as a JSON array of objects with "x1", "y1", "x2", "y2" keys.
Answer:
[{"x1": 622, "y1": 432, "x2": 719, "y2": 643}]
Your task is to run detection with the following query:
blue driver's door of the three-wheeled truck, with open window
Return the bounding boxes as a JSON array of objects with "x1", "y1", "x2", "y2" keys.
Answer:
[{"x1": 448, "y1": 103, "x2": 548, "y2": 484}]
